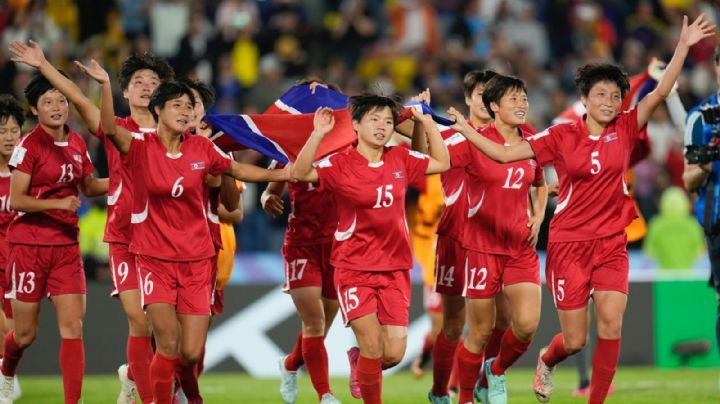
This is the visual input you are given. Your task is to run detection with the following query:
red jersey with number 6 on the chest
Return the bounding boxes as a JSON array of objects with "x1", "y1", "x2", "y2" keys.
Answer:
[{"x1": 126, "y1": 133, "x2": 232, "y2": 261}]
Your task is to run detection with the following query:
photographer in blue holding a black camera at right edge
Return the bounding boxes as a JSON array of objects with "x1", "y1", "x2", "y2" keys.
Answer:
[{"x1": 683, "y1": 47, "x2": 720, "y2": 360}]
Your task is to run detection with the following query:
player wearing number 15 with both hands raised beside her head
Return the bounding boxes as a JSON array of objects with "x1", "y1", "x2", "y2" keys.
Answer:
[{"x1": 293, "y1": 95, "x2": 449, "y2": 403}]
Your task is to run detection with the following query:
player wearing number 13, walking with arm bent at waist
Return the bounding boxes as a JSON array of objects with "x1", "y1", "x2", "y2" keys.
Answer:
[{"x1": 0, "y1": 75, "x2": 108, "y2": 403}]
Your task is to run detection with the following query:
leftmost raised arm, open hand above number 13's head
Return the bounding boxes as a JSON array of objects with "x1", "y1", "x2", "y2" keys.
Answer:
[{"x1": 9, "y1": 40, "x2": 100, "y2": 133}]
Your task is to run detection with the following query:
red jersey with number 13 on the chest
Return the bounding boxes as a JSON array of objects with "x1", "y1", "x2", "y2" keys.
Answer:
[{"x1": 8, "y1": 125, "x2": 95, "y2": 245}]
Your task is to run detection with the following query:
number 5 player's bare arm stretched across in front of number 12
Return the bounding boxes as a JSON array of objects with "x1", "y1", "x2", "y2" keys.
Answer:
[{"x1": 448, "y1": 107, "x2": 535, "y2": 163}]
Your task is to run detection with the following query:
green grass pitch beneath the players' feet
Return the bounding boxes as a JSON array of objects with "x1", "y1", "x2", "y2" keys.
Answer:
[{"x1": 16, "y1": 366, "x2": 720, "y2": 404}]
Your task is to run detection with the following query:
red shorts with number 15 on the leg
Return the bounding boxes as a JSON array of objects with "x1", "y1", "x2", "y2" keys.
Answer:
[{"x1": 335, "y1": 268, "x2": 411, "y2": 327}]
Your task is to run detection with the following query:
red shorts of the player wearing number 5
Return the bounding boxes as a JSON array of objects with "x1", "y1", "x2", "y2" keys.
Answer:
[{"x1": 545, "y1": 232, "x2": 629, "y2": 310}]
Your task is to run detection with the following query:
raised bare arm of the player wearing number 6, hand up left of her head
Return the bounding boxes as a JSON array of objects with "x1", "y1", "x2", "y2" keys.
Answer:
[{"x1": 83, "y1": 59, "x2": 132, "y2": 154}]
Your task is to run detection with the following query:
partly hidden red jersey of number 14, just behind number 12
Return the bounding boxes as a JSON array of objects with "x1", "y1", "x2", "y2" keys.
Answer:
[{"x1": 437, "y1": 132, "x2": 468, "y2": 241}]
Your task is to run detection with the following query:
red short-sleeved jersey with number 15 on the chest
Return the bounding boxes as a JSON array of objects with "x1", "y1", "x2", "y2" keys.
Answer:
[{"x1": 316, "y1": 147, "x2": 430, "y2": 271}]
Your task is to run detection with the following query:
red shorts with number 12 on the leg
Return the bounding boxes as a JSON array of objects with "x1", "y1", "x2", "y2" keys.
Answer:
[{"x1": 463, "y1": 247, "x2": 540, "y2": 299}]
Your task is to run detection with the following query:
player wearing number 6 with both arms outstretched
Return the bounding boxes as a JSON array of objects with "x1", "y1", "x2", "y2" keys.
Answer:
[{"x1": 90, "y1": 60, "x2": 288, "y2": 404}]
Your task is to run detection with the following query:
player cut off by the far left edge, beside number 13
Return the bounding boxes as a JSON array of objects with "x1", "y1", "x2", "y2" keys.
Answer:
[{"x1": 0, "y1": 94, "x2": 25, "y2": 400}]
